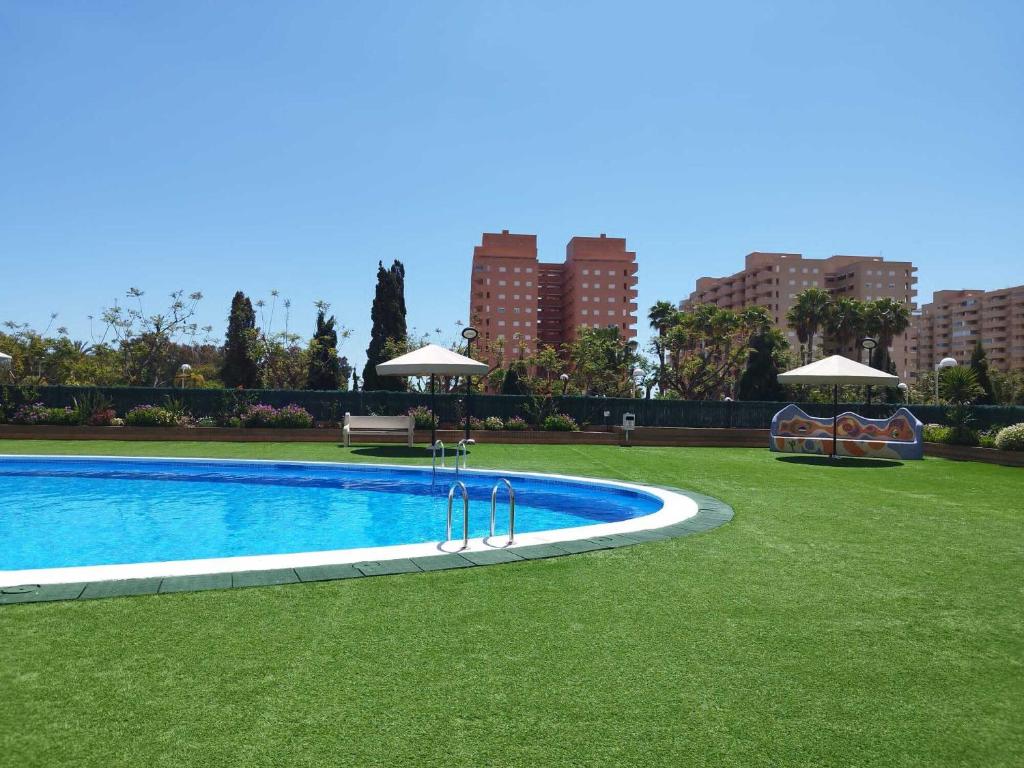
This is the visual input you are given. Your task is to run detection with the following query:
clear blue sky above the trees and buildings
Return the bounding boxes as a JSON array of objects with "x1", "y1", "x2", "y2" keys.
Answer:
[{"x1": 0, "y1": 0, "x2": 1024, "y2": 365}]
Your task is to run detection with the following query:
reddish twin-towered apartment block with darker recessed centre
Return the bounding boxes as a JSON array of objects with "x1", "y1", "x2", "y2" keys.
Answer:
[{"x1": 469, "y1": 229, "x2": 637, "y2": 361}]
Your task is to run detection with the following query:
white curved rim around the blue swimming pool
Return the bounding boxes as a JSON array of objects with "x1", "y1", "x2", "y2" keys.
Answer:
[{"x1": 0, "y1": 454, "x2": 698, "y2": 589}]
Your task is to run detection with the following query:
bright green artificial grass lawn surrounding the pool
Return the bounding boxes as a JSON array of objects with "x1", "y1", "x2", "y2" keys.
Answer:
[{"x1": 0, "y1": 441, "x2": 1024, "y2": 768}]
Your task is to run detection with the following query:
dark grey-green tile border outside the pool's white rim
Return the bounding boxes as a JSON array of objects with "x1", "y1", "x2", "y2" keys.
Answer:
[{"x1": 0, "y1": 460, "x2": 733, "y2": 605}]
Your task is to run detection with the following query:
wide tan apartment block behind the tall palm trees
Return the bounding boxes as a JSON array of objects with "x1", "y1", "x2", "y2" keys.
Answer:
[{"x1": 681, "y1": 252, "x2": 918, "y2": 377}]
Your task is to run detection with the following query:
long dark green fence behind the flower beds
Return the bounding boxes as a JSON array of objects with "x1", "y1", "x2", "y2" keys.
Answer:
[{"x1": 0, "y1": 386, "x2": 1024, "y2": 428}]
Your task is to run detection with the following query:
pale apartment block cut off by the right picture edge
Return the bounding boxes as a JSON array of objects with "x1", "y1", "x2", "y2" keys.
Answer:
[{"x1": 910, "y1": 286, "x2": 1024, "y2": 372}]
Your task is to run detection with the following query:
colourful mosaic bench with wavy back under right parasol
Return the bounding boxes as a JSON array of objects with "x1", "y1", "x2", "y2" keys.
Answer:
[{"x1": 771, "y1": 404, "x2": 925, "y2": 459}]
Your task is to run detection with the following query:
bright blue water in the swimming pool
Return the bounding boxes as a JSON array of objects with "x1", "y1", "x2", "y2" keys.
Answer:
[{"x1": 0, "y1": 457, "x2": 662, "y2": 570}]
